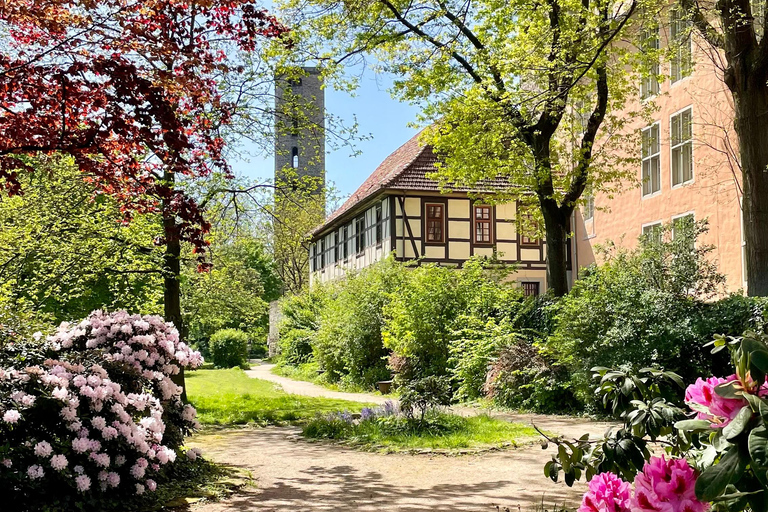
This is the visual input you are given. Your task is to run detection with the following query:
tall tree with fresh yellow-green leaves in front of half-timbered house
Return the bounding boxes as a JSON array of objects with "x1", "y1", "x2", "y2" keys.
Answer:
[{"x1": 274, "y1": 0, "x2": 638, "y2": 295}]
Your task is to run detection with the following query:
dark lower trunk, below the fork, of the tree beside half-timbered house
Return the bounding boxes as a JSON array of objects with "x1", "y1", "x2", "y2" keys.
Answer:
[{"x1": 539, "y1": 197, "x2": 569, "y2": 297}]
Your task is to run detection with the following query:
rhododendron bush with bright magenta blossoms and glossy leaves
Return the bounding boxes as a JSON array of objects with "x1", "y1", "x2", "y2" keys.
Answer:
[{"x1": 545, "y1": 333, "x2": 768, "y2": 512}]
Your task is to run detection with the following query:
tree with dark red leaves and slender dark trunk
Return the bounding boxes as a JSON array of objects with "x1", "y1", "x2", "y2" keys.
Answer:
[{"x1": 0, "y1": 0, "x2": 290, "y2": 394}]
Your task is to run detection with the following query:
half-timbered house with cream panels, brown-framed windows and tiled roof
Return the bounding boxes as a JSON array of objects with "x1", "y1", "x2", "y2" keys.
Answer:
[{"x1": 310, "y1": 130, "x2": 564, "y2": 295}]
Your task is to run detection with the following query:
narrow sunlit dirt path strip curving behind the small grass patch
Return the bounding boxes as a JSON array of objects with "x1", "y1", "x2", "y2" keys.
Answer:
[{"x1": 245, "y1": 364, "x2": 612, "y2": 438}]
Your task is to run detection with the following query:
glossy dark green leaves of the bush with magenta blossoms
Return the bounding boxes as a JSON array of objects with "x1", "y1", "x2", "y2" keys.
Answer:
[{"x1": 545, "y1": 332, "x2": 768, "y2": 512}]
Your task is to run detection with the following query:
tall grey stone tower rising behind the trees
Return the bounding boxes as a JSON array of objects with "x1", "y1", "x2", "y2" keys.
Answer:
[{"x1": 275, "y1": 67, "x2": 325, "y2": 194}]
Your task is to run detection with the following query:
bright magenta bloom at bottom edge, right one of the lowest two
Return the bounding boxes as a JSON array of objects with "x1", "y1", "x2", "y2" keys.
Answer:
[{"x1": 631, "y1": 456, "x2": 709, "y2": 512}]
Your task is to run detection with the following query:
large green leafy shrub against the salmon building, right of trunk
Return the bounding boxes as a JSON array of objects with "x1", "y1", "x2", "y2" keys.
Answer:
[{"x1": 544, "y1": 222, "x2": 732, "y2": 403}]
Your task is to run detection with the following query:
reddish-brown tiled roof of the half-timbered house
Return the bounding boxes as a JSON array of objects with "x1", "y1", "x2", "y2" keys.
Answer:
[{"x1": 312, "y1": 132, "x2": 509, "y2": 235}]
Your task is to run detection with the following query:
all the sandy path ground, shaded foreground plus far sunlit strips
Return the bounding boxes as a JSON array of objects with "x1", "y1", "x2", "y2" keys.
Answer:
[{"x1": 190, "y1": 365, "x2": 608, "y2": 512}]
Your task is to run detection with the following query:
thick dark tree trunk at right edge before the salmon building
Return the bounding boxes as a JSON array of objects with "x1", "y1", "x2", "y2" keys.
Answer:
[{"x1": 731, "y1": 83, "x2": 768, "y2": 296}]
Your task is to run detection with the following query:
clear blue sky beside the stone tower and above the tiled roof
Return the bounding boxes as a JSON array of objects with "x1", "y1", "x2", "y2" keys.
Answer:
[{"x1": 231, "y1": 72, "x2": 418, "y2": 197}]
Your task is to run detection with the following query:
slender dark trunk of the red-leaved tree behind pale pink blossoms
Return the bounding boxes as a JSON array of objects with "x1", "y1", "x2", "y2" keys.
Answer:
[{"x1": 163, "y1": 173, "x2": 187, "y2": 402}]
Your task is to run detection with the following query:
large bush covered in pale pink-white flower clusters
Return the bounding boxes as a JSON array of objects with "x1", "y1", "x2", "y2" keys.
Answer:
[{"x1": 0, "y1": 311, "x2": 202, "y2": 494}]
